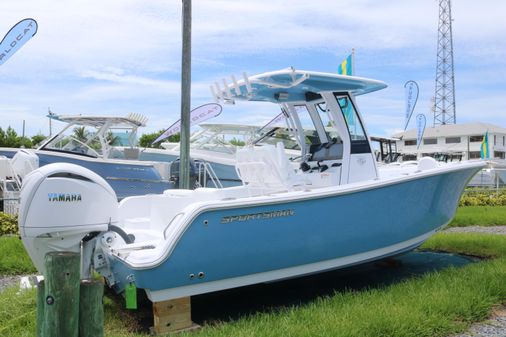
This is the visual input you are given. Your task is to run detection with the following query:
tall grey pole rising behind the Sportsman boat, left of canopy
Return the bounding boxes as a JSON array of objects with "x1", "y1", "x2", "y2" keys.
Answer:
[{"x1": 179, "y1": 0, "x2": 191, "y2": 189}]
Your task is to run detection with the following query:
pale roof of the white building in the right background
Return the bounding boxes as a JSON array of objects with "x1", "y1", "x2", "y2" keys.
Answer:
[{"x1": 392, "y1": 123, "x2": 506, "y2": 139}]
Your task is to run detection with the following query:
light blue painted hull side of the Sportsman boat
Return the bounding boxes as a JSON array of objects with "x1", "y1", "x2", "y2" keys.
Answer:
[{"x1": 108, "y1": 168, "x2": 477, "y2": 294}]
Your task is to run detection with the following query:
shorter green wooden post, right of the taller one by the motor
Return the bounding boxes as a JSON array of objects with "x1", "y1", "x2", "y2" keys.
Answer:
[{"x1": 79, "y1": 280, "x2": 104, "y2": 337}]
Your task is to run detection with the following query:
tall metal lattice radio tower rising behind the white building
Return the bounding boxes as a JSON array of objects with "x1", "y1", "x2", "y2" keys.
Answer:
[{"x1": 434, "y1": 0, "x2": 457, "y2": 126}]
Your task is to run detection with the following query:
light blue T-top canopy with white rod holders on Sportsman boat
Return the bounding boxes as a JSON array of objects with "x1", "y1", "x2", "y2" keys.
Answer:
[{"x1": 211, "y1": 68, "x2": 387, "y2": 103}]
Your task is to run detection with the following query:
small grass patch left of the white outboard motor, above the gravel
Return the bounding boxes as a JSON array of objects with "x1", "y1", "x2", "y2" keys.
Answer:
[{"x1": 0, "y1": 236, "x2": 35, "y2": 274}]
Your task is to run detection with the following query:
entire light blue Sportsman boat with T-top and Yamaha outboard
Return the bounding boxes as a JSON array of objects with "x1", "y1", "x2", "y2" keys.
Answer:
[{"x1": 19, "y1": 69, "x2": 485, "y2": 302}]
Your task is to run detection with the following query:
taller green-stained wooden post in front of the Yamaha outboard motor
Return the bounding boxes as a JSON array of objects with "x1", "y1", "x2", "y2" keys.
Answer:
[{"x1": 42, "y1": 252, "x2": 81, "y2": 337}]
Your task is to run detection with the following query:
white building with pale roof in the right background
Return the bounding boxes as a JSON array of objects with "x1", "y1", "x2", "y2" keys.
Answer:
[{"x1": 393, "y1": 123, "x2": 506, "y2": 160}]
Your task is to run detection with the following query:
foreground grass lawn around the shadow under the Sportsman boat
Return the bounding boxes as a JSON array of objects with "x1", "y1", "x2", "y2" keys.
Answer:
[{"x1": 0, "y1": 233, "x2": 506, "y2": 337}]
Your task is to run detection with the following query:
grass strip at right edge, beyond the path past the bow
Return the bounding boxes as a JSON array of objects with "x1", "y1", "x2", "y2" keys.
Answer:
[{"x1": 448, "y1": 206, "x2": 506, "y2": 227}]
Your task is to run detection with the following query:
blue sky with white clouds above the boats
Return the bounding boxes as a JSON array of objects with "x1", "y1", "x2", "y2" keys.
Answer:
[{"x1": 0, "y1": 0, "x2": 506, "y2": 136}]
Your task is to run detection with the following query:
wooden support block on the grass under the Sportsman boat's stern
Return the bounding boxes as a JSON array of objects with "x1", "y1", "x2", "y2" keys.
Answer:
[{"x1": 152, "y1": 297, "x2": 199, "y2": 335}]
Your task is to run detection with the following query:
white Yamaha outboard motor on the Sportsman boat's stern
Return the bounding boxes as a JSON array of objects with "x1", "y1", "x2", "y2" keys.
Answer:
[{"x1": 19, "y1": 163, "x2": 118, "y2": 273}]
